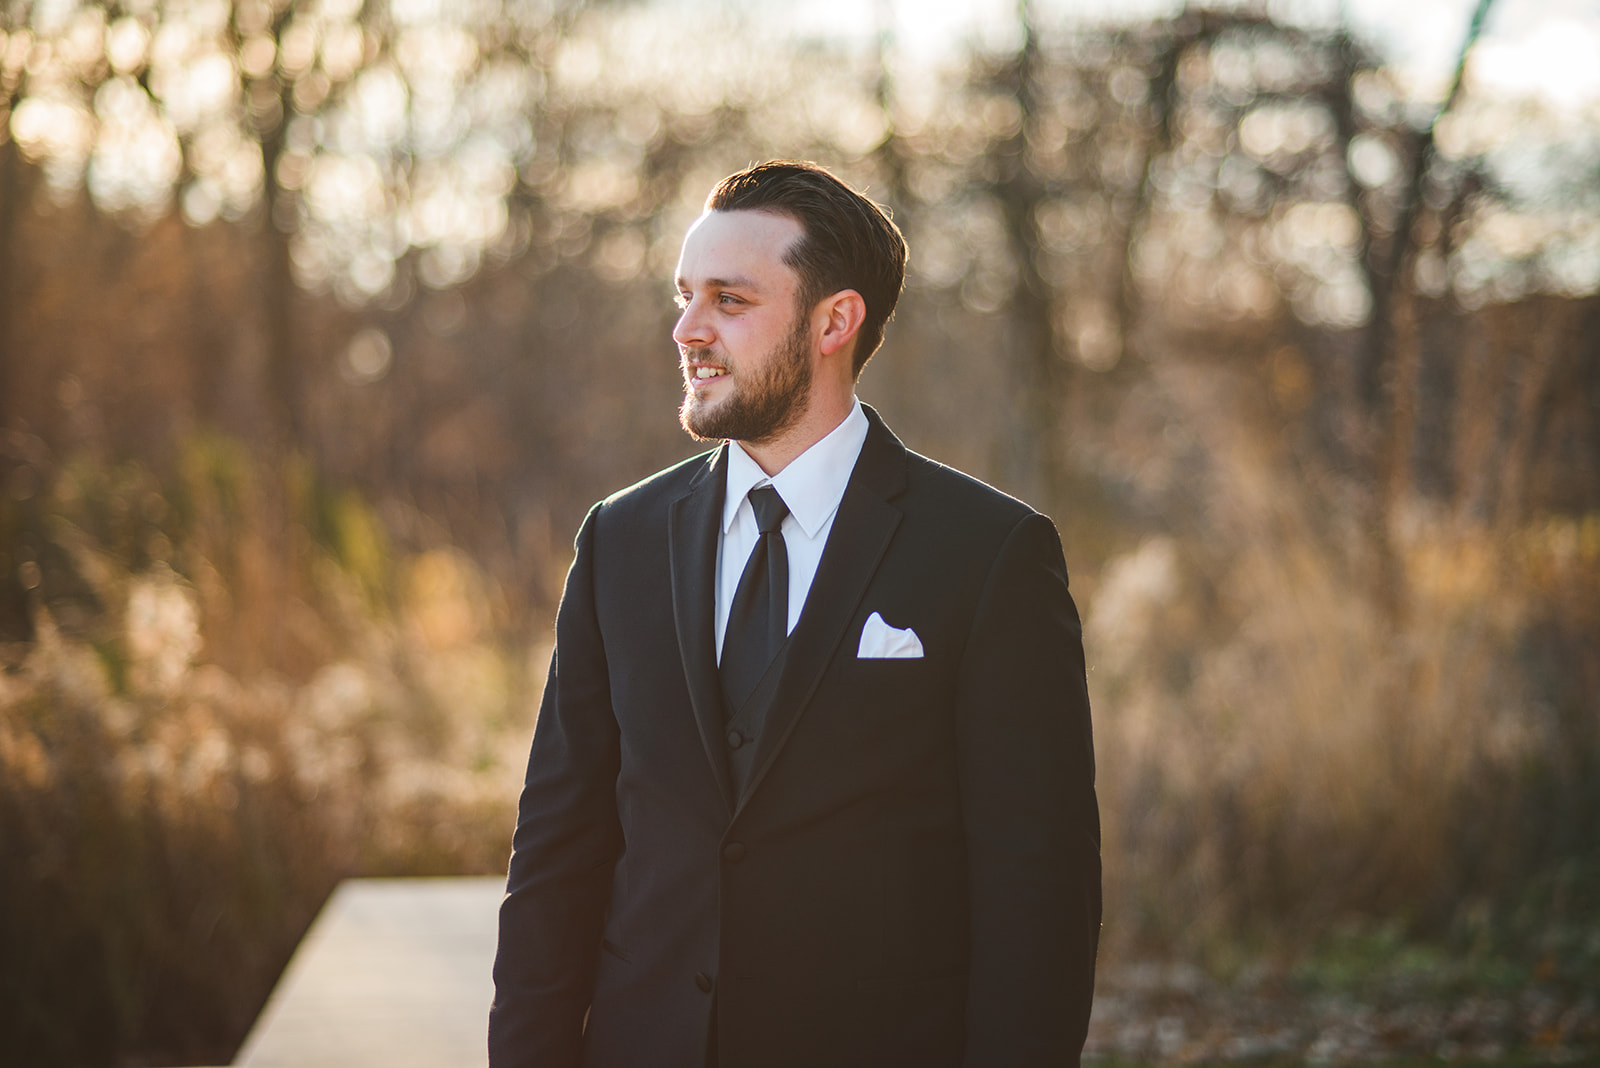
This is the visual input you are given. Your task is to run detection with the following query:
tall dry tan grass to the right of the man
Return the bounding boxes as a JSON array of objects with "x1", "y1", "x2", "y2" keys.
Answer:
[{"x1": 1086, "y1": 370, "x2": 1600, "y2": 982}]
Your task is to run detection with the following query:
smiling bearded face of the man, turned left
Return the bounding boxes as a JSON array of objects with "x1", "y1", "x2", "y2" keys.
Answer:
[{"x1": 672, "y1": 211, "x2": 814, "y2": 444}]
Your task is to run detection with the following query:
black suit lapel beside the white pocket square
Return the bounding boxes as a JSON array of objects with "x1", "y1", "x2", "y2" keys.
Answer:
[{"x1": 739, "y1": 404, "x2": 907, "y2": 807}]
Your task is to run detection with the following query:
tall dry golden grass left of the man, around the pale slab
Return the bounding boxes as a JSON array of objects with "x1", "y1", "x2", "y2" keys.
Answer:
[{"x1": 0, "y1": 438, "x2": 544, "y2": 1065}]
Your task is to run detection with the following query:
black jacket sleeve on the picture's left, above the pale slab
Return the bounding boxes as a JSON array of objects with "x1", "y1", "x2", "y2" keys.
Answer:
[{"x1": 488, "y1": 505, "x2": 622, "y2": 1068}]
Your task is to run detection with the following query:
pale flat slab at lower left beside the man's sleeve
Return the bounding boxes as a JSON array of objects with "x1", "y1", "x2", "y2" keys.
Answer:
[{"x1": 234, "y1": 876, "x2": 506, "y2": 1068}]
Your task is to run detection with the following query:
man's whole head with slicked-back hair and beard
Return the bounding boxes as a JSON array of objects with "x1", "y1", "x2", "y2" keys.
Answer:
[{"x1": 672, "y1": 163, "x2": 906, "y2": 470}]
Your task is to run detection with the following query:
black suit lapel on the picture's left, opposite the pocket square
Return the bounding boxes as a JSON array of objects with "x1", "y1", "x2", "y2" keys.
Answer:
[{"x1": 667, "y1": 444, "x2": 734, "y2": 812}]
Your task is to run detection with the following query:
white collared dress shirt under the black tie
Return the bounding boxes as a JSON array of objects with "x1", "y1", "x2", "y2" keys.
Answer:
[{"x1": 717, "y1": 400, "x2": 867, "y2": 664}]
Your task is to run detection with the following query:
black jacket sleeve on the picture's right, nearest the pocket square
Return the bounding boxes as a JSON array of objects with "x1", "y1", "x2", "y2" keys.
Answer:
[{"x1": 957, "y1": 513, "x2": 1101, "y2": 1068}]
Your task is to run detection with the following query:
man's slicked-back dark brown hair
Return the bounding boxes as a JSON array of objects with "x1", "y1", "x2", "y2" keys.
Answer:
[{"x1": 706, "y1": 160, "x2": 906, "y2": 379}]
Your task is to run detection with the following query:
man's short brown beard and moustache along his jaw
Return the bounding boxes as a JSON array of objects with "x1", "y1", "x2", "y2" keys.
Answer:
[{"x1": 678, "y1": 308, "x2": 811, "y2": 444}]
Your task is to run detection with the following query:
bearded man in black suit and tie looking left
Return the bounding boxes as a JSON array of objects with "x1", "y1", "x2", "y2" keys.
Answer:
[{"x1": 490, "y1": 161, "x2": 1099, "y2": 1068}]
